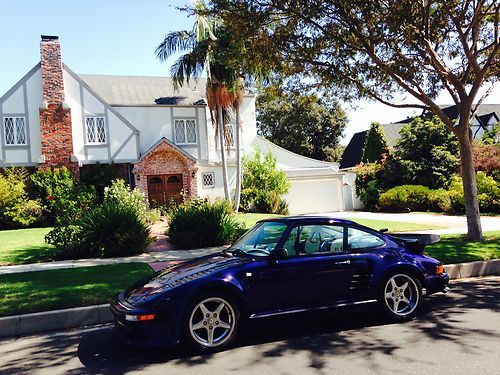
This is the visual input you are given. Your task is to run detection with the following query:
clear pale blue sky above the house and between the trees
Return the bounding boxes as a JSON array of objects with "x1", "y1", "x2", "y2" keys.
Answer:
[{"x1": 0, "y1": 0, "x2": 500, "y2": 144}]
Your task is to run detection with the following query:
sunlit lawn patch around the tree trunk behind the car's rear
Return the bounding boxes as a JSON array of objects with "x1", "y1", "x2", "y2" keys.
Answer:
[{"x1": 425, "y1": 231, "x2": 500, "y2": 264}]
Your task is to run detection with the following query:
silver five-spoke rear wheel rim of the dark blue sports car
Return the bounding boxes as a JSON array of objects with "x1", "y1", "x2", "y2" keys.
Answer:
[{"x1": 380, "y1": 272, "x2": 422, "y2": 321}]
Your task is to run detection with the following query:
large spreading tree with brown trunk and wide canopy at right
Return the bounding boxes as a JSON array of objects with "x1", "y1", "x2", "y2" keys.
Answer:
[{"x1": 213, "y1": 0, "x2": 500, "y2": 241}]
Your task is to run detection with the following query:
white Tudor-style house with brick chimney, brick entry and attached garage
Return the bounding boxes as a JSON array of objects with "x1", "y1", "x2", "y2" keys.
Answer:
[{"x1": 0, "y1": 36, "x2": 352, "y2": 213}]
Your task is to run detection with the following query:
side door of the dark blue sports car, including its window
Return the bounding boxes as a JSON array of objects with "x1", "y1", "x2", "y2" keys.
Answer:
[{"x1": 249, "y1": 222, "x2": 352, "y2": 313}]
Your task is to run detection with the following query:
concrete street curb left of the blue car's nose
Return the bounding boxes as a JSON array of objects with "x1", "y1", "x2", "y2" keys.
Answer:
[{"x1": 0, "y1": 304, "x2": 113, "y2": 337}]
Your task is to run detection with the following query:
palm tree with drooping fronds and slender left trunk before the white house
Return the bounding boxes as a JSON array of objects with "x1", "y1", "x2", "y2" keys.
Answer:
[{"x1": 156, "y1": 0, "x2": 235, "y2": 200}]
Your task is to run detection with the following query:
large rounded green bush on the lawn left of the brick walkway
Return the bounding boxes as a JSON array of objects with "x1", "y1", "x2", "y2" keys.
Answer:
[{"x1": 46, "y1": 202, "x2": 150, "y2": 259}]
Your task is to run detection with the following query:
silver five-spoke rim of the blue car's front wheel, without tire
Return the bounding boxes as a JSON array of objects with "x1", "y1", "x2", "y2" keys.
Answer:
[{"x1": 189, "y1": 297, "x2": 236, "y2": 348}]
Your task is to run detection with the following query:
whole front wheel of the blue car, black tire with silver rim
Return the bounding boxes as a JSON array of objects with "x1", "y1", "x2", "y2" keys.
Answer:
[{"x1": 182, "y1": 292, "x2": 240, "y2": 353}]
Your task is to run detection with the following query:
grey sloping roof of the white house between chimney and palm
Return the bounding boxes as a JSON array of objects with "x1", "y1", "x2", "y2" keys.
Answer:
[{"x1": 78, "y1": 74, "x2": 207, "y2": 106}]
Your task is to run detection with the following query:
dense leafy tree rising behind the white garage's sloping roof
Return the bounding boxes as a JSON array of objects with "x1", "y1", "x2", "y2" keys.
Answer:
[{"x1": 256, "y1": 86, "x2": 348, "y2": 161}]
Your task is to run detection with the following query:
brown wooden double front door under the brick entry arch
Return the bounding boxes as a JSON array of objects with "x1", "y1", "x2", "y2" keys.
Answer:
[{"x1": 148, "y1": 174, "x2": 183, "y2": 206}]
